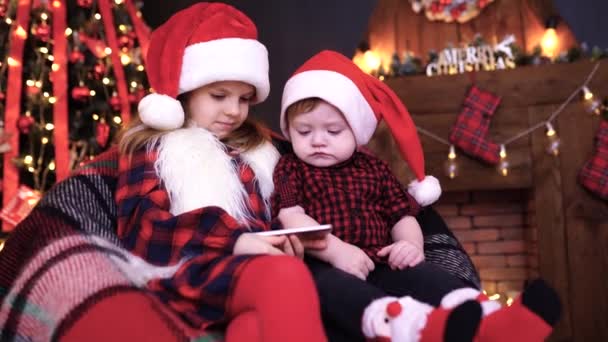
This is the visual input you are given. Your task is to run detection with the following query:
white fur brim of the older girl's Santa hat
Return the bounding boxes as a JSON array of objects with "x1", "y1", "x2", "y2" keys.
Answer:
[{"x1": 178, "y1": 38, "x2": 270, "y2": 103}]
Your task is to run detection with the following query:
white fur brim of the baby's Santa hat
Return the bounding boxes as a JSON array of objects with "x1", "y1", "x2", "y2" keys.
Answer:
[{"x1": 281, "y1": 70, "x2": 378, "y2": 145}]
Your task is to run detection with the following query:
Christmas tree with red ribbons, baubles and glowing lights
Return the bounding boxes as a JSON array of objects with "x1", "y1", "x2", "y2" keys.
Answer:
[{"x1": 0, "y1": 0, "x2": 150, "y2": 231}]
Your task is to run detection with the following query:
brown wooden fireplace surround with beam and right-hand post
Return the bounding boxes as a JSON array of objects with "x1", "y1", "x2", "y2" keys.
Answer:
[{"x1": 369, "y1": 61, "x2": 608, "y2": 341}]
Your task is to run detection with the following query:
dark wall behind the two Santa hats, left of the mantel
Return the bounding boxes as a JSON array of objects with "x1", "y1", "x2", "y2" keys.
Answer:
[{"x1": 142, "y1": 0, "x2": 376, "y2": 131}]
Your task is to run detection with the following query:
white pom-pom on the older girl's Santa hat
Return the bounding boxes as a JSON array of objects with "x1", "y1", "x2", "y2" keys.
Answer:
[{"x1": 137, "y1": 93, "x2": 184, "y2": 131}]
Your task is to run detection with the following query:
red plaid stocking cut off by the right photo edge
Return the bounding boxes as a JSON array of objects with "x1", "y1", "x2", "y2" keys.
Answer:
[{"x1": 579, "y1": 120, "x2": 608, "y2": 200}]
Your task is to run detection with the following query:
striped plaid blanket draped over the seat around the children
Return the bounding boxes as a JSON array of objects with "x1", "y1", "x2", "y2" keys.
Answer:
[{"x1": 0, "y1": 140, "x2": 479, "y2": 342}]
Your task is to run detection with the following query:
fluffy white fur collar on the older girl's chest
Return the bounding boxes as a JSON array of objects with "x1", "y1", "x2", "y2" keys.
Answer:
[{"x1": 155, "y1": 127, "x2": 278, "y2": 223}]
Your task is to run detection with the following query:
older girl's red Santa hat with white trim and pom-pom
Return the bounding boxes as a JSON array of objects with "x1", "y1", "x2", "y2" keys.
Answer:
[{"x1": 138, "y1": 2, "x2": 270, "y2": 130}]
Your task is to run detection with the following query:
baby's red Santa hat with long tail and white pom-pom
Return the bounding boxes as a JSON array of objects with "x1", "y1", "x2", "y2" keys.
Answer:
[{"x1": 281, "y1": 50, "x2": 441, "y2": 206}]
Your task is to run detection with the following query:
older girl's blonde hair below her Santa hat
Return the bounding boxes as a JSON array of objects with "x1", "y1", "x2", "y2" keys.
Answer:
[{"x1": 118, "y1": 93, "x2": 271, "y2": 156}]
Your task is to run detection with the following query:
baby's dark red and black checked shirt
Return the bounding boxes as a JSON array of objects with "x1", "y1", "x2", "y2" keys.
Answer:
[{"x1": 271, "y1": 152, "x2": 420, "y2": 262}]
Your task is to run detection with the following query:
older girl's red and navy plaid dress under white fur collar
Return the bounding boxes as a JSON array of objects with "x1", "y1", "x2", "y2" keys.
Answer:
[{"x1": 116, "y1": 146, "x2": 269, "y2": 329}]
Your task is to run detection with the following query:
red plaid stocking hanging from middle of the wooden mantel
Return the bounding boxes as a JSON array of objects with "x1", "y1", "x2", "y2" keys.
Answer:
[{"x1": 449, "y1": 86, "x2": 500, "y2": 165}]
